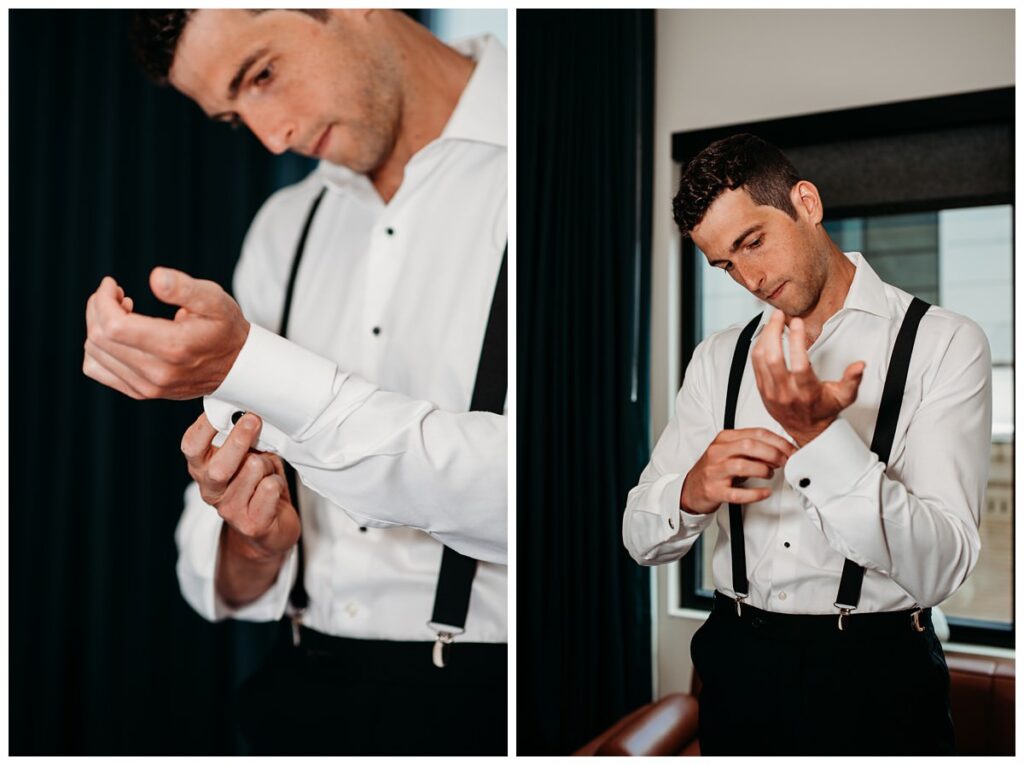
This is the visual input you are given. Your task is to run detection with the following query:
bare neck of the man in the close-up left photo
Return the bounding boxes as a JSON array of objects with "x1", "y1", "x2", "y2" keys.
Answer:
[{"x1": 370, "y1": 18, "x2": 475, "y2": 202}]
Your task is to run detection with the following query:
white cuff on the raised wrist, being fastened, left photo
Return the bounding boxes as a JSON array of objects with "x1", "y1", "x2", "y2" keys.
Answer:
[{"x1": 208, "y1": 324, "x2": 337, "y2": 438}]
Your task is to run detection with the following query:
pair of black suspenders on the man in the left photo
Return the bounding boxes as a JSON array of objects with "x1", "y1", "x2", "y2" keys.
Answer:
[{"x1": 279, "y1": 188, "x2": 508, "y2": 667}]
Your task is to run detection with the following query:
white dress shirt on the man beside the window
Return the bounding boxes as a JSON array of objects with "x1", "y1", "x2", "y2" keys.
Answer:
[{"x1": 623, "y1": 253, "x2": 992, "y2": 613}]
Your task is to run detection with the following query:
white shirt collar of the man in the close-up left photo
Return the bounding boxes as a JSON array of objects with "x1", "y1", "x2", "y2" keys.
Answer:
[{"x1": 316, "y1": 35, "x2": 508, "y2": 192}]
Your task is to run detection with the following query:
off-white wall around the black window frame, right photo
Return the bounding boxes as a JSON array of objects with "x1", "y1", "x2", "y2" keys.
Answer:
[{"x1": 651, "y1": 5, "x2": 1014, "y2": 695}]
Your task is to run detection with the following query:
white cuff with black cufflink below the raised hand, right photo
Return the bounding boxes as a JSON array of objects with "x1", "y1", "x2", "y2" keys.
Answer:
[{"x1": 784, "y1": 418, "x2": 879, "y2": 509}]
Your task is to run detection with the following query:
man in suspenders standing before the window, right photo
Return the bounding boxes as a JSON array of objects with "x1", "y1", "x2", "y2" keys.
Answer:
[{"x1": 623, "y1": 135, "x2": 991, "y2": 755}]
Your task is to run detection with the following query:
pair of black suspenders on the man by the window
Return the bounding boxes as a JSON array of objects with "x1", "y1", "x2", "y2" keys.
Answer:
[{"x1": 724, "y1": 298, "x2": 931, "y2": 614}]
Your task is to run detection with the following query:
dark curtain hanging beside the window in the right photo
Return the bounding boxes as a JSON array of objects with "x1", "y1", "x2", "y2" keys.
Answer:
[{"x1": 515, "y1": 10, "x2": 655, "y2": 755}]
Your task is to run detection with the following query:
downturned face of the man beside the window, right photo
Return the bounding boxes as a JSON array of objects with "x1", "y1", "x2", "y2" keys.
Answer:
[{"x1": 690, "y1": 184, "x2": 828, "y2": 316}]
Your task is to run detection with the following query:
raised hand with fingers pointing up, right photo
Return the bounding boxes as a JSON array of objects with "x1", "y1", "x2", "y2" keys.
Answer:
[{"x1": 751, "y1": 310, "x2": 864, "y2": 447}]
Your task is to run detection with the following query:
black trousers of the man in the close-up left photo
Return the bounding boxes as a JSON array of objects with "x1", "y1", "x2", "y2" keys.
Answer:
[{"x1": 239, "y1": 628, "x2": 508, "y2": 755}]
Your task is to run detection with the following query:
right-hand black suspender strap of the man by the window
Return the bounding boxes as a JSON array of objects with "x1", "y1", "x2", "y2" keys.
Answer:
[{"x1": 836, "y1": 298, "x2": 931, "y2": 614}]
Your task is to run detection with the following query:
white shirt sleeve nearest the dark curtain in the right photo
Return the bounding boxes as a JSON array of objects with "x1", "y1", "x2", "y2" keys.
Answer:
[{"x1": 623, "y1": 341, "x2": 721, "y2": 565}]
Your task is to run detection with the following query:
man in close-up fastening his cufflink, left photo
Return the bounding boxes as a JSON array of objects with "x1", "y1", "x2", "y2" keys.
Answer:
[{"x1": 83, "y1": 9, "x2": 507, "y2": 754}]
